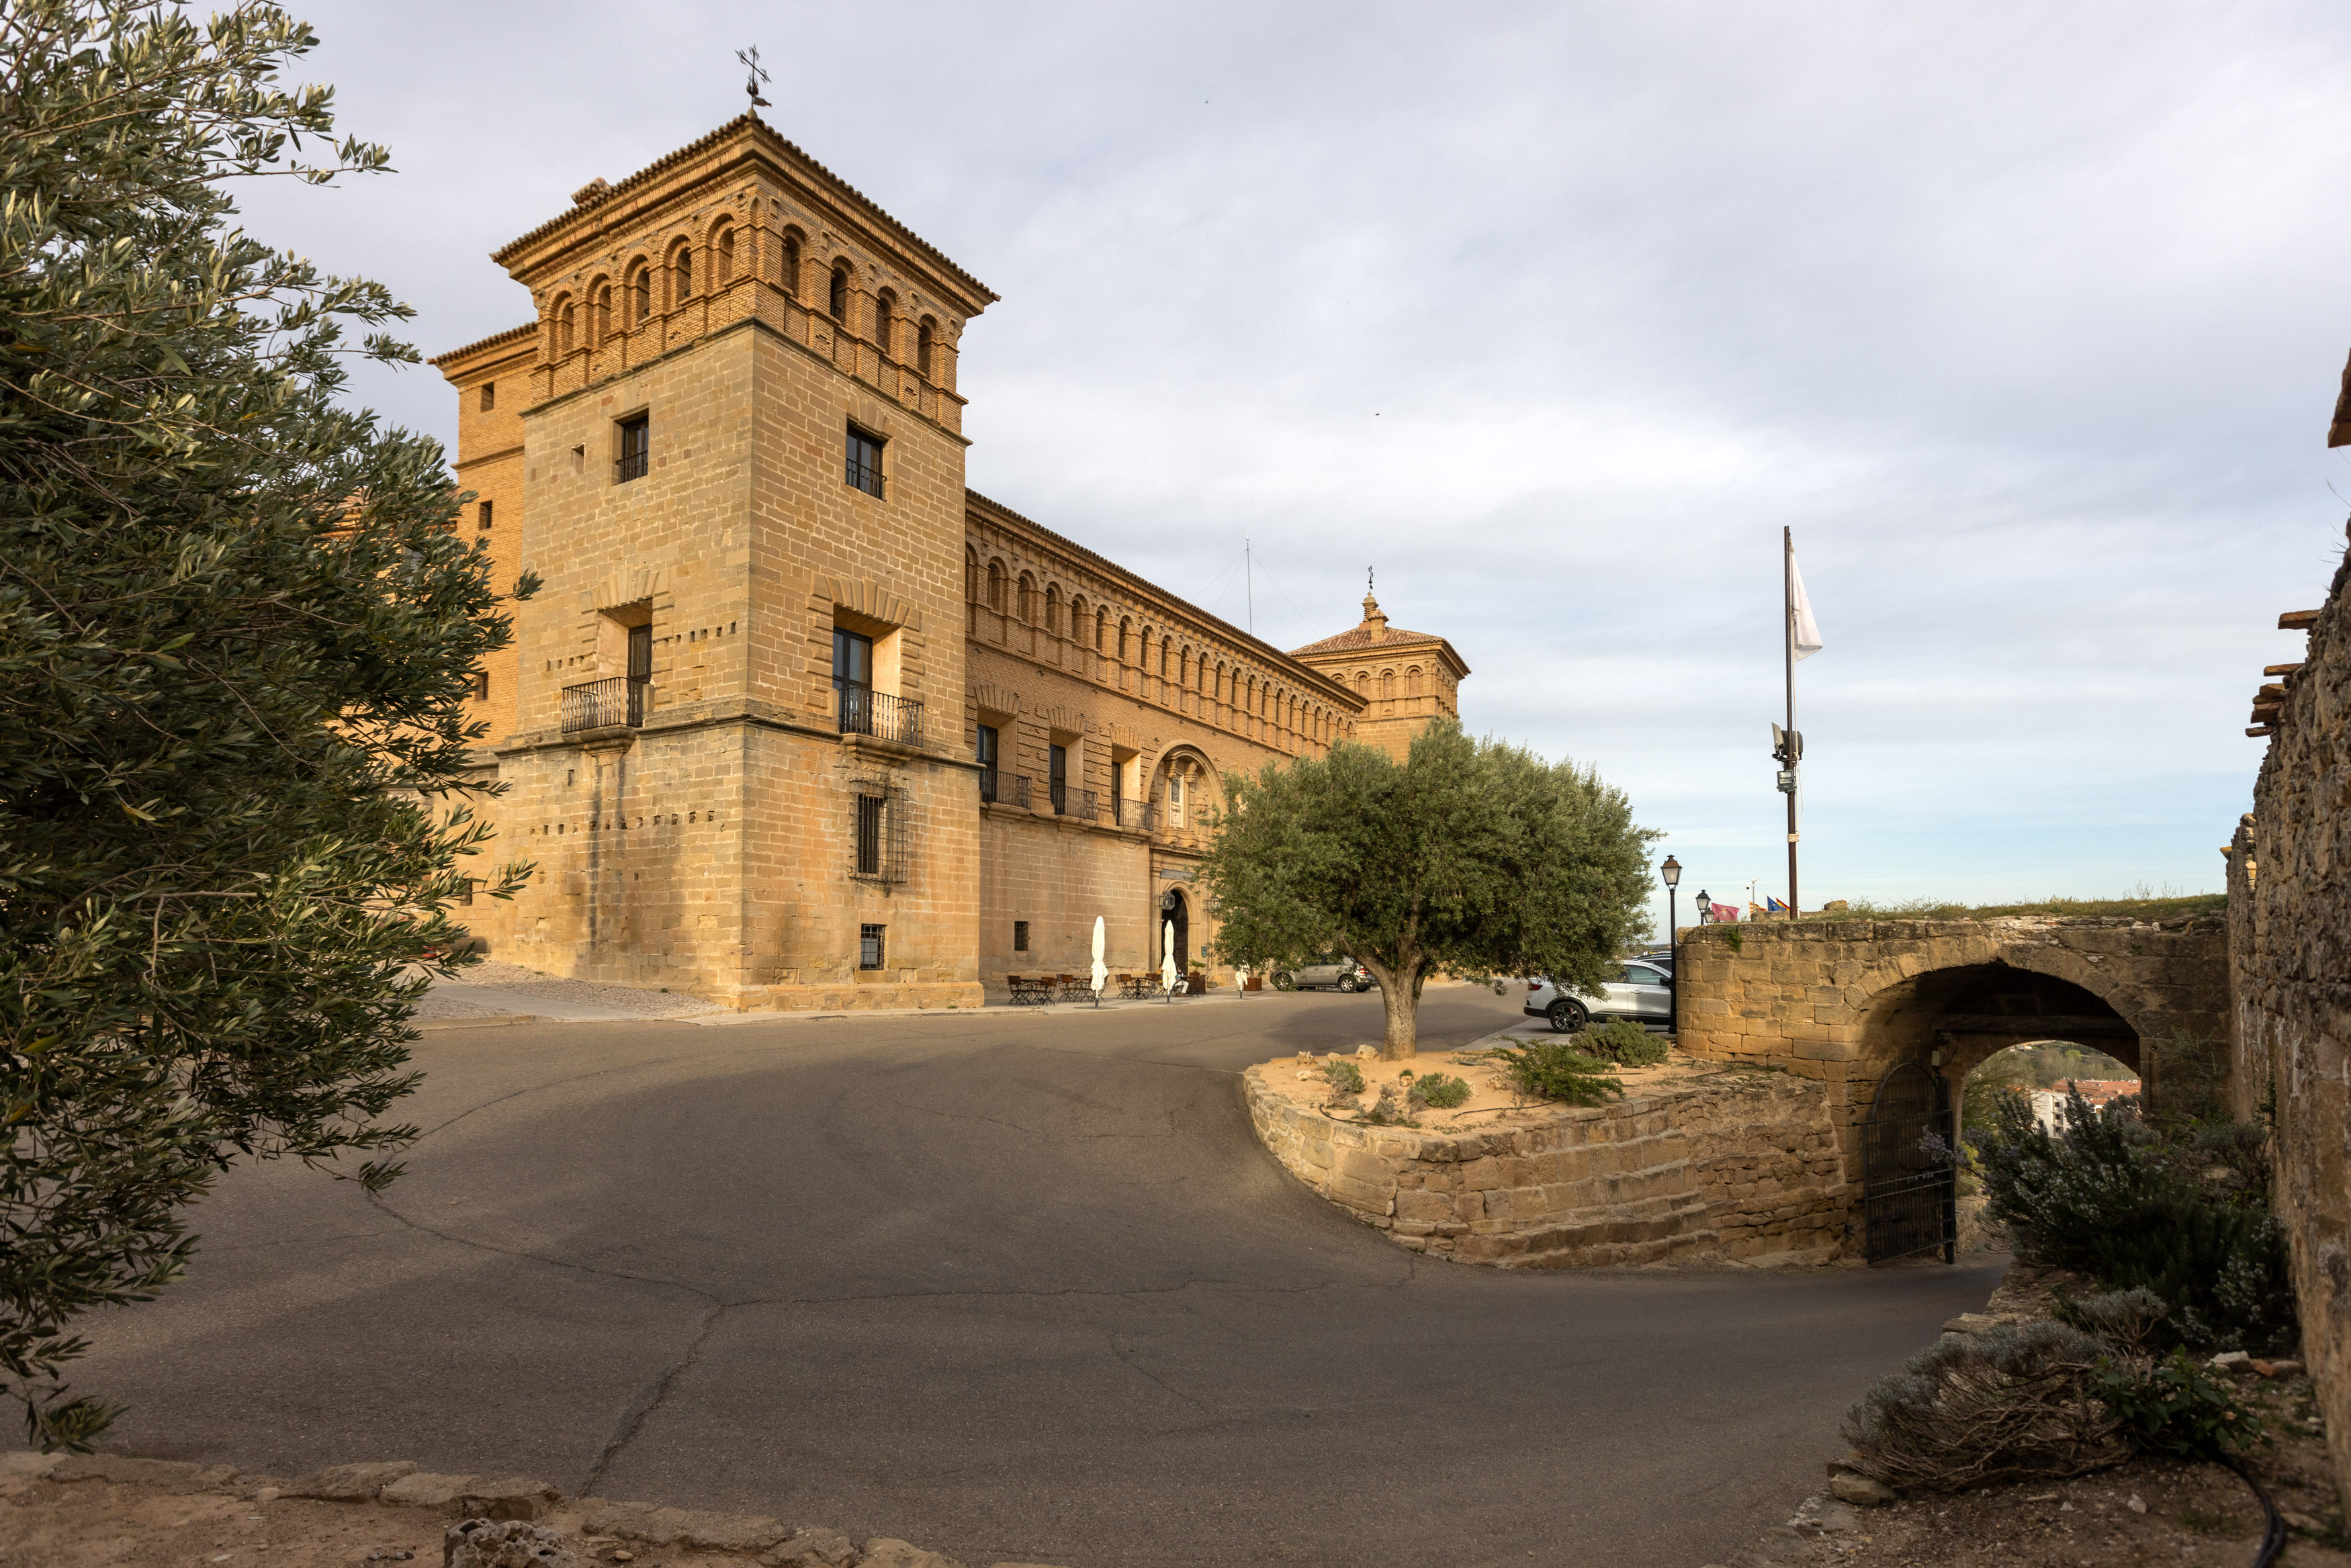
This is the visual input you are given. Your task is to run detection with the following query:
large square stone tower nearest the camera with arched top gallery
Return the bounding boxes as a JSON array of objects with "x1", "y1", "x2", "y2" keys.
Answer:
[{"x1": 435, "y1": 116, "x2": 997, "y2": 1006}]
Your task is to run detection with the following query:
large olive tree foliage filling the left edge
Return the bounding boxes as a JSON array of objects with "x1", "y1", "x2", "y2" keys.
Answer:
[{"x1": 0, "y1": 0, "x2": 529, "y2": 1448}]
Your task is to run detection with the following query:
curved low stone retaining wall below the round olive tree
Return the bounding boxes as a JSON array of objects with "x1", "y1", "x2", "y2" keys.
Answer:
[{"x1": 1241, "y1": 1065, "x2": 1851, "y2": 1269}]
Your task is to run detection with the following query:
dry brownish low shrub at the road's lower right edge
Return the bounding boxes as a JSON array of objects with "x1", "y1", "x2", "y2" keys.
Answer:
[{"x1": 1846, "y1": 1324, "x2": 2130, "y2": 1493}]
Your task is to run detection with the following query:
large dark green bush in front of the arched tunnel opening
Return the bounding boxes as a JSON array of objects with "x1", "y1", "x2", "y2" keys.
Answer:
[{"x1": 1973, "y1": 1091, "x2": 2297, "y2": 1352}]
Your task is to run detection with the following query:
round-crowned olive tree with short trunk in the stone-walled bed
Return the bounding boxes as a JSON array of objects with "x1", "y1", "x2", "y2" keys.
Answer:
[{"x1": 1199, "y1": 724, "x2": 1660, "y2": 1060}]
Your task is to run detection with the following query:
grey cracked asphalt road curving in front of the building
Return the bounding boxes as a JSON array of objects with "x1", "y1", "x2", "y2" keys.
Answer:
[{"x1": 75, "y1": 987, "x2": 1994, "y2": 1568}]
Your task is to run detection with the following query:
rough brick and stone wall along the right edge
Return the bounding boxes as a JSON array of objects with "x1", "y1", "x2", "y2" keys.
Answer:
[{"x1": 2229, "y1": 536, "x2": 2351, "y2": 1500}]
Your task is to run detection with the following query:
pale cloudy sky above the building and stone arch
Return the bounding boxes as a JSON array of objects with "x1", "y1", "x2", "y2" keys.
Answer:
[{"x1": 247, "y1": 0, "x2": 2351, "y2": 917}]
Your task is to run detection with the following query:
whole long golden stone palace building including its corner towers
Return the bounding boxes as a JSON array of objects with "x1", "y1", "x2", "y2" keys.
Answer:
[{"x1": 435, "y1": 116, "x2": 1470, "y2": 1009}]
